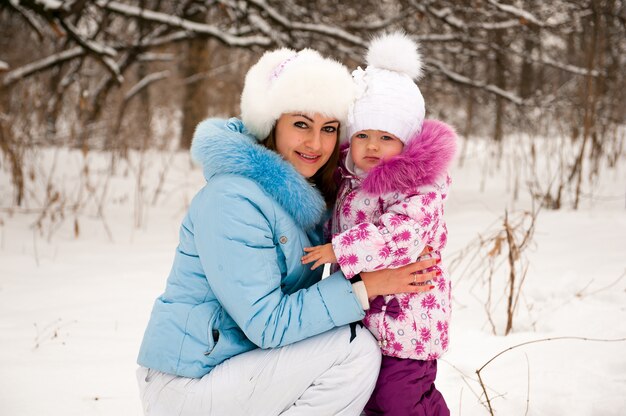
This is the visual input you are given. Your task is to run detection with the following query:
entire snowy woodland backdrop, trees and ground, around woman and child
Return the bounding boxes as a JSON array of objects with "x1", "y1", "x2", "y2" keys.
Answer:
[{"x1": 0, "y1": 0, "x2": 626, "y2": 416}]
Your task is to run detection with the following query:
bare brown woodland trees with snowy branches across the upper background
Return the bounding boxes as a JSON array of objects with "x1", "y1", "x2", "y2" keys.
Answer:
[{"x1": 0, "y1": 0, "x2": 626, "y2": 206}]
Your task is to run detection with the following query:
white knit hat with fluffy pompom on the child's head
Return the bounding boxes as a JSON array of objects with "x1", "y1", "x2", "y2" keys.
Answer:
[{"x1": 347, "y1": 32, "x2": 425, "y2": 144}]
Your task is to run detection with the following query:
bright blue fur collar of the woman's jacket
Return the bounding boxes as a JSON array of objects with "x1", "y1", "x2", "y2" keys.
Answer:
[{"x1": 191, "y1": 118, "x2": 325, "y2": 229}]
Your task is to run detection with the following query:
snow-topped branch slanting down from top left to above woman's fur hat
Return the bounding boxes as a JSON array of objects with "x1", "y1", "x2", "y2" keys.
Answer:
[{"x1": 96, "y1": 0, "x2": 271, "y2": 47}]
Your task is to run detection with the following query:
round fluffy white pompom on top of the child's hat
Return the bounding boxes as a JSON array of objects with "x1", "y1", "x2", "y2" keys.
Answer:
[{"x1": 366, "y1": 32, "x2": 422, "y2": 79}]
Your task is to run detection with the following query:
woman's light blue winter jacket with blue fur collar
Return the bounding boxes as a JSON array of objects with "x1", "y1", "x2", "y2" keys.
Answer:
[{"x1": 138, "y1": 119, "x2": 364, "y2": 378}]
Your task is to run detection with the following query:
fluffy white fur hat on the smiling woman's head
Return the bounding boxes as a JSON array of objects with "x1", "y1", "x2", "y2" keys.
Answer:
[{"x1": 241, "y1": 48, "x2": 355, "y2": 140}]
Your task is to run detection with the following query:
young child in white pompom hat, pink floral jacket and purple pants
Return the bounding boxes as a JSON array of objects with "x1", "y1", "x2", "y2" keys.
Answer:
[{"x1": 302, "y1": 33, "x2": 456, "y2": 416}]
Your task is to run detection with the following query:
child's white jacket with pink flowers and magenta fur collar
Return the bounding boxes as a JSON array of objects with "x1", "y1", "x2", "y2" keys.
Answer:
[{"x1": 331, "y1": 120, "x2": 456, "y2": 360}]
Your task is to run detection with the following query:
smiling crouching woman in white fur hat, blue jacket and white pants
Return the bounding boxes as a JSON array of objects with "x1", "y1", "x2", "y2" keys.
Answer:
[{"x1": 137, "y1": 49, "x2": 435, "y2": 415}]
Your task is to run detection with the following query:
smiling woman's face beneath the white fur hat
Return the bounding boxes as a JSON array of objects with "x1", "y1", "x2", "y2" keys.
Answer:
[{"x1": 275, "y1": 113, "x2": 339, "y2": 178}]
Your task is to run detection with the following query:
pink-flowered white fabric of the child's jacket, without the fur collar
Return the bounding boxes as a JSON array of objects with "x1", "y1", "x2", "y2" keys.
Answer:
[{"x1": 331, "y1": 174, "x2": 451, "y2": 360}]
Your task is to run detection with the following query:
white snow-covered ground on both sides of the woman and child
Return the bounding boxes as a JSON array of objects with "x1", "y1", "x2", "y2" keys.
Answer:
[{"x1": 0, "y1": 144, "x2": 626, "y2": 416}]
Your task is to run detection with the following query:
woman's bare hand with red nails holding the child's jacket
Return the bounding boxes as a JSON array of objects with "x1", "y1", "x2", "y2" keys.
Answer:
[{"x1": 361, "y1": 249, "x2": 441, "y2": 298}]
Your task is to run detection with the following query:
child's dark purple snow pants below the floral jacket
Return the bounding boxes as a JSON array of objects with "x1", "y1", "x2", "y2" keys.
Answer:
[{"x1": 365, "y1": 355, "x2": 450, "y2": 416}]
